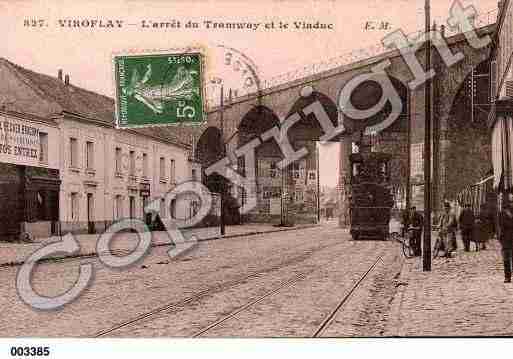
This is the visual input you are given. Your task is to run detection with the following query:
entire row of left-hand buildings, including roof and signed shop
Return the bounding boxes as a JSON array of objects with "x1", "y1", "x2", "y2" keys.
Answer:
[{"x1": 0, "y1": 59, "x2": 201, "y2": 238}]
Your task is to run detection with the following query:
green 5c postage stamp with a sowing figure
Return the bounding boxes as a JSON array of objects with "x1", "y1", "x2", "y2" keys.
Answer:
[{"x1": 114, "y1": 52, "x2": 206, "y2": 128}]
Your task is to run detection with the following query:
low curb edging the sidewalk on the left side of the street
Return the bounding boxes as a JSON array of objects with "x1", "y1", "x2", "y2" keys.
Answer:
[{"x1": 0, "y1": 224, "x2": 320, "y2": 268}]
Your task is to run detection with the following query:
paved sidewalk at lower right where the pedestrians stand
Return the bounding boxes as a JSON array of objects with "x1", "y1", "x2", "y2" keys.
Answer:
[{"x1": 385, "y1": 240, "x2": 513, "y2": 337}]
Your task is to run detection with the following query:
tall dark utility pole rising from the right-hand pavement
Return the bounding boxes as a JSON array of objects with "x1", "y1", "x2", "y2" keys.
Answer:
[{"x1": 422, "y1": 0, "x2": 432, "y2": 272}]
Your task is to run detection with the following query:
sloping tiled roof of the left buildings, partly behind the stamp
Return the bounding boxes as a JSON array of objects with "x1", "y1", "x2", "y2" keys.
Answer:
[{"x1": 0, "y1": 57, "x2": 192, "y2": 148}]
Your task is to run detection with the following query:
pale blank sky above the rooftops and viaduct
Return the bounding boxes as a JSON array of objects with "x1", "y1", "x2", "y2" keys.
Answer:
[{"x1": 0, "y1": 0, "x2": 498, "y2": 187}]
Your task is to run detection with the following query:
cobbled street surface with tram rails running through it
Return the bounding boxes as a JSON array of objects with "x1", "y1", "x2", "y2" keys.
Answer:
[{"x1": 0, "y1": 222, "x2": 403, "y2": 337}]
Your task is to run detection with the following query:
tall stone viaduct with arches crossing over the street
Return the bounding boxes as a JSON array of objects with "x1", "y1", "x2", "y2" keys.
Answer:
[{"x1": 183, "y1": 25, "x2": 494, "y2": 225}]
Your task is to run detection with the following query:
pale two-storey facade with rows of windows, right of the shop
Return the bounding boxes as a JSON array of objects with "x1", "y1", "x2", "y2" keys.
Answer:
[{"x1": 58, "y1": 116, "x2": 197, "y2": 233}]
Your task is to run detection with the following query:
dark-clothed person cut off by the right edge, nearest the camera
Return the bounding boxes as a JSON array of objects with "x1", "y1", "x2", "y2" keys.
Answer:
[{"x1": 499, "y1": 193, "x2": 513, "y2": 283}]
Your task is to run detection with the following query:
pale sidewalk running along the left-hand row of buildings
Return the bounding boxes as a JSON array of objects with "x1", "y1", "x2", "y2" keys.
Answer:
[{"x1": 0, "y1": 224, "x2": 318, "y2": 266}]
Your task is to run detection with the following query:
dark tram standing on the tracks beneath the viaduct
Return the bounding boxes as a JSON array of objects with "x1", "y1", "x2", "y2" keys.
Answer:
[{"x1": 349, "y1": 151, "x2": 394, "y2": 240}]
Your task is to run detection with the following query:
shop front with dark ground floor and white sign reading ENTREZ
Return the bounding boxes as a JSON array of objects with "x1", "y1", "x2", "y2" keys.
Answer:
[{"x1": 0, "y1": 112, "x2": 60, "y2": 240}]
